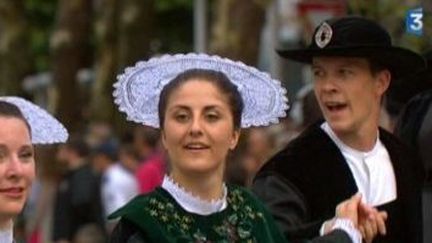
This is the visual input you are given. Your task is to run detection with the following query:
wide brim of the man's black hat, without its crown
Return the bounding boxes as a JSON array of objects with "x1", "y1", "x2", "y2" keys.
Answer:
[{"x1": 276, "y1": 46, "x2": 426, "y2": 79}]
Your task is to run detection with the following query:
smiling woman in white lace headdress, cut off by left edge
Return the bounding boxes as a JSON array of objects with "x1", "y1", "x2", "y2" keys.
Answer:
[{"x1": 0, "y1": 96, "x2": 68, "y2": 243}]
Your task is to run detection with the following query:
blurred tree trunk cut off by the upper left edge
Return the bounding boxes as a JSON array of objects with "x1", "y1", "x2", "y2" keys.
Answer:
[{"x1": 0, "y1": 0, "x2": 33, "y2": 95}]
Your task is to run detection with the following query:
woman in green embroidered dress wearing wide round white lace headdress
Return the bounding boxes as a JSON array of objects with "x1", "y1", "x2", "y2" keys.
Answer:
[{"x1": 110, "y1": 54, "x2": 384, "y2": 243}]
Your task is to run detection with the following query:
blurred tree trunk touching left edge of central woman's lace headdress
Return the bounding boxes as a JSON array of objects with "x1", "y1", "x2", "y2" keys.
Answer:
[{"x1": 92, "y1": 0, "x2": 154, "y2": 133}]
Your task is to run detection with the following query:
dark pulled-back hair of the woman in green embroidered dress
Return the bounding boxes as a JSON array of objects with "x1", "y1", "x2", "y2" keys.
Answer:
[{"x1": 158, "y1": 69, "x2": 244, "y2": 129}]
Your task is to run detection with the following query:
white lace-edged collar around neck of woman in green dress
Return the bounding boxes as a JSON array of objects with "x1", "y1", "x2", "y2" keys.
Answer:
[{"x1": 162, "y1": 175, "x2": 227, "y2": 215}]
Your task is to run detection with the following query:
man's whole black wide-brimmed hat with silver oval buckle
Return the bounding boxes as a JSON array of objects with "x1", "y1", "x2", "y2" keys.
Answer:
[{"x1": 277, "y1": 16, "x2": 426, "y2": 79}]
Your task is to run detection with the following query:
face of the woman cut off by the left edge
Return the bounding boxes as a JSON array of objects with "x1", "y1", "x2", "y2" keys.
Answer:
[{"x1": 0, "y1": 116, "x2": 35, "y2": 221}]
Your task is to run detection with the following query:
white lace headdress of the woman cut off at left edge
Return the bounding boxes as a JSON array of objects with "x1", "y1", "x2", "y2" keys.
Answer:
[{"x1": 0, "y1": 96, "x2": 69, "y2": 144}]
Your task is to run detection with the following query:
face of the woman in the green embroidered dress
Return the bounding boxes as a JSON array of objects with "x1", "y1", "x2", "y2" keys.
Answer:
[{"x1": 162, "y1": 79, "x2": 239, "y2": 175}]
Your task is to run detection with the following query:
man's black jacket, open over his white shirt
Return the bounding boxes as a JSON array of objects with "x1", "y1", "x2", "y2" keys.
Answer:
[{"x1": 253, "y1": 123, "x2": 423, "y2": 243}]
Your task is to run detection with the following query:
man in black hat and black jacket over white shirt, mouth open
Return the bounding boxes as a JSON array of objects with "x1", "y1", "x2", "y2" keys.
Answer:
[{"x1": 253, "y1": 17, "x2": 425, "y2": 243}]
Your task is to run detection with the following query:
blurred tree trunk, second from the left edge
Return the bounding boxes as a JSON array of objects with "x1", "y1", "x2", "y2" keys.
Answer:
[{"x1": 50, "y1": 0, "x2": 92, "y2": 131}]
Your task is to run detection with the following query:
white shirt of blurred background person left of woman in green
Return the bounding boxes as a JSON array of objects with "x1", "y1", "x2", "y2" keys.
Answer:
[{"x1": 101, "y1": 163, "x2": 138, "y2": 216}]
